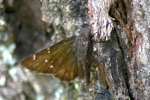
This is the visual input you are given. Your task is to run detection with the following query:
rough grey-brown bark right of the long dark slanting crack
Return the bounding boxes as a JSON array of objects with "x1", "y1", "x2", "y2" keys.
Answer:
[{"x1": 105, "y1": 0, "x2": 149, "y2": 100}]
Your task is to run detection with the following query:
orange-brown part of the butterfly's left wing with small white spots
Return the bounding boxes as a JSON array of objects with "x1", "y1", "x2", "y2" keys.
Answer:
[{"x1": 22, "y1": 37, "x2": 81, "y2": 81}]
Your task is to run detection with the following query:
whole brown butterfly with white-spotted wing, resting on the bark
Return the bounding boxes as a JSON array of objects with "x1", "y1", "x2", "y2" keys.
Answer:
[{"x1": 21, "y1": 33, "x2": 111, "y2": 91}]
